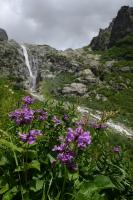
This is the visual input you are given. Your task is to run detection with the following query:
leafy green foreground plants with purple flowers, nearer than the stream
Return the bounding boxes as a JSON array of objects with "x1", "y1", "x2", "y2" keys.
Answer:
[{"x1": 0, "y1": 97, "x2": 133, "y2": 200}]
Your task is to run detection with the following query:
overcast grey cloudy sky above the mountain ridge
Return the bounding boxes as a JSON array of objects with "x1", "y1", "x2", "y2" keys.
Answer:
[{"x1": 0, "y1": 0, "x2": 133, "y2": 49}]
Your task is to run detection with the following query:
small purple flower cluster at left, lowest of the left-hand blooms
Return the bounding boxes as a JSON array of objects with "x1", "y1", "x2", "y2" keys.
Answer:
[{"x1": 19, "y1": 130, "x2": 42, "y2": 144}]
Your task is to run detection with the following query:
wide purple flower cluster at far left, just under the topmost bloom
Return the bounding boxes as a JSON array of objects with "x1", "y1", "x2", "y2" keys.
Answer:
[{"x1": 9, "y1": 107, "x2": 34, "y2": 125}]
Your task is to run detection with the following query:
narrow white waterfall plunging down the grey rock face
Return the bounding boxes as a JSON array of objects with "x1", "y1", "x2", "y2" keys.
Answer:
[{"x1": 21, "y1": 45, "x2": 37, "y2": 92}]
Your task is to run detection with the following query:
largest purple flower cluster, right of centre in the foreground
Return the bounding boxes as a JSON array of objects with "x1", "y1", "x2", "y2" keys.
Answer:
[{"x1": 52, "y1": 127, "x2": 91, "y2": 170}]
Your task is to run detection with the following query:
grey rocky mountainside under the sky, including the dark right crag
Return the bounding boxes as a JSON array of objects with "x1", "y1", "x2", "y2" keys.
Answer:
[{"x1": 0, "y1": 3, "x2": 133, "y2": 101}]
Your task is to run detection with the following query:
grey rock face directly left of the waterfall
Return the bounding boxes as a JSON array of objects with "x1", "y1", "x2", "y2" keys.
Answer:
[{"x1": 0, "y1": 41, "x2": 27, "y2": 82}]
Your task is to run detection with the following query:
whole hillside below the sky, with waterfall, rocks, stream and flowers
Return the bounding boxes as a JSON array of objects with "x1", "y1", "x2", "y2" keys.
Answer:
[{"x1": 0, "y1": 6, "x2": 133, "y2": 200}]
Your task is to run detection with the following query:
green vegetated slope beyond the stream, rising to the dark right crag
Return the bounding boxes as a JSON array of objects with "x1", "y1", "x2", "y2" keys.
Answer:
[{"x1": 39, "y1": 35, "x2": 133, "y2": 128}]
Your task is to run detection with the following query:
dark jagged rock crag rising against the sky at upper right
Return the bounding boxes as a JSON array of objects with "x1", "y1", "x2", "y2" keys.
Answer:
[{"x1": 90, "y1": 6, "x2": 133, "y2": 50}]
